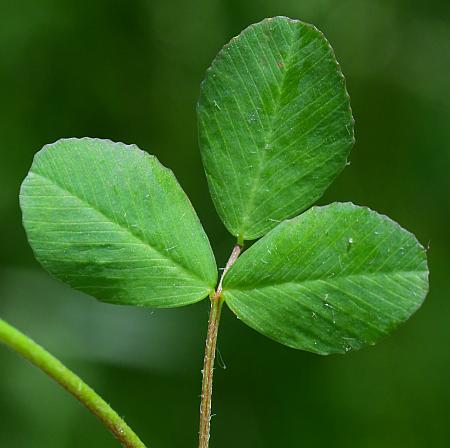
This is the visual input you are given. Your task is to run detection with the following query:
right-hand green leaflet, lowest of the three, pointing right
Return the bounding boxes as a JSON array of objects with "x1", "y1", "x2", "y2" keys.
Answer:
[{"x1": 223, "y1": 203, "x2": 428, "y2": 354}]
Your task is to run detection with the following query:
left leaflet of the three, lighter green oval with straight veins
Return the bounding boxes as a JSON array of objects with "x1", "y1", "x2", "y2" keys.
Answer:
[{"x1": 20, "y1": 138, "x2": 217, "y2": 307}]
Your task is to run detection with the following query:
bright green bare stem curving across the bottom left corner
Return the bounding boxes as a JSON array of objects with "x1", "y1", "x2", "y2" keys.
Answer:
[{"x1": 0, "y1": 319, "x2": 145, "y2": 448}]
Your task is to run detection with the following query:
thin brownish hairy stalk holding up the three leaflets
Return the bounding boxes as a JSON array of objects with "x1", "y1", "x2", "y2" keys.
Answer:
[{"x1": 199, "y1": 244, "x2": 242, "y2": 448}]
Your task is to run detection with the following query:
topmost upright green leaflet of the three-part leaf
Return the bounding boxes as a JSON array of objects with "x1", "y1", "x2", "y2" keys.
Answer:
[{"x1": 198, "y1": 17, "x2": 354, "y2": 241}]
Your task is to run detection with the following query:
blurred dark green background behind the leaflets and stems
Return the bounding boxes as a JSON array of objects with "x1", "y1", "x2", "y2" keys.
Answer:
[{"x1": 0, "y1": 0, "x2": 450, "y2": 448}]
